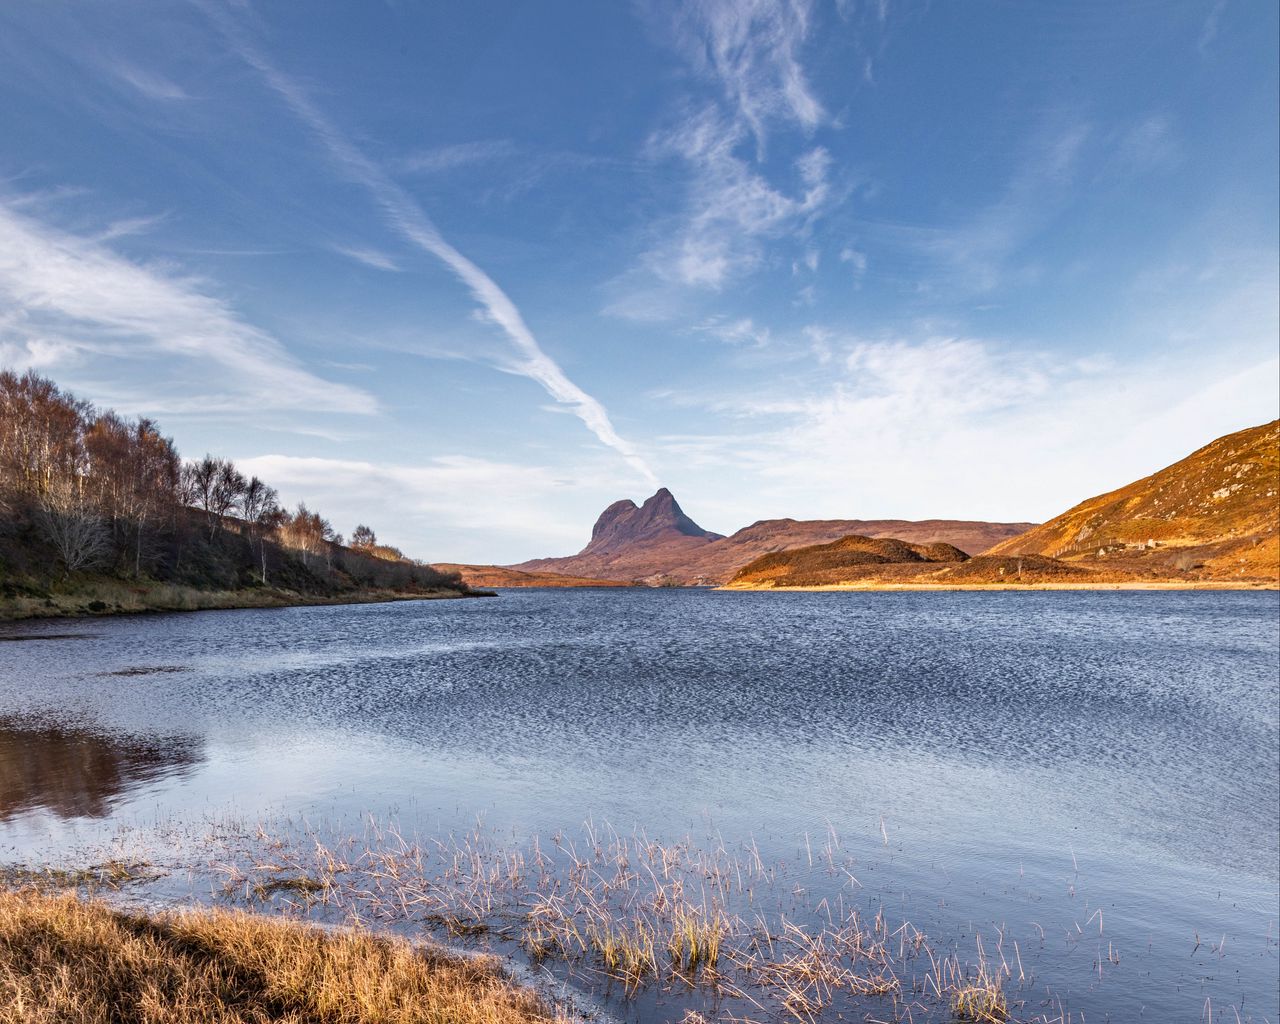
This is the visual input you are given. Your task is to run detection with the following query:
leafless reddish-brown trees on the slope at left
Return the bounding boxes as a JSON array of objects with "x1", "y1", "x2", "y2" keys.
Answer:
[{"x1": 0, "y1": 371, "x2": 460, "y2": 586}]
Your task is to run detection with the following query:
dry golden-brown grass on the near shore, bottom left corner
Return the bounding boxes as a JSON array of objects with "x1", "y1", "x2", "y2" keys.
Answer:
[{"x1": 0, "y1": 888, "x2": 557, "y2": 1024}]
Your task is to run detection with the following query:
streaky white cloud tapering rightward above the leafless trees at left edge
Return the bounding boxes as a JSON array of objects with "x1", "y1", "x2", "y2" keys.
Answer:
[{"x1": 0, "y1": 204, "x2": 375, "y2": 413}]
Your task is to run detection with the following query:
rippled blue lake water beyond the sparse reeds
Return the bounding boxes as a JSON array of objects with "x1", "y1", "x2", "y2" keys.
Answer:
[{"x1": 0, "y1": 590, "x2": 1280, "y2": 1021}]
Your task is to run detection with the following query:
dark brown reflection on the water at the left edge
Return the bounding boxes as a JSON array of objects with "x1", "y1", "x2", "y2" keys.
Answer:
[{"x1": 0, "y1": 718, "x2": 202, "y2": 820}]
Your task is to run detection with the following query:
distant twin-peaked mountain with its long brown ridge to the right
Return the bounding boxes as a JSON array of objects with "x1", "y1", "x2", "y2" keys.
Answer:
[{"x1": 512, "y1": 488, "x2": 1033, "y2": 585}]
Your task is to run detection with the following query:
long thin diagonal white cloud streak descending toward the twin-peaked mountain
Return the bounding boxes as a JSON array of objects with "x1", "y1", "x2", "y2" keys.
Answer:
[{"x1": 202, "y1": 4, "x2": 657, "y2": 481}]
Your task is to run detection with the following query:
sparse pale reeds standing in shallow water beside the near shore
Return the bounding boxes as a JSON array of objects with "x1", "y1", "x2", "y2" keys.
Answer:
[{"x1": 0, "y1": 815, "x2": 1115, "y2": 1024}]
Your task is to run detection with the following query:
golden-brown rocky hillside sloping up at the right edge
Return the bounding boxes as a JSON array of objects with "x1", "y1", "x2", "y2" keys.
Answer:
[{"x1": 988, "y1": 421, "x2": 1280, "y2": 581}]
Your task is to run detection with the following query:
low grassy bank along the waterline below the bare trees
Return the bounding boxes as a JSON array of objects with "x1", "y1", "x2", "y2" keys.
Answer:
[{"x1": 0, "y1": 579, "x2": 492, "y2": 622}]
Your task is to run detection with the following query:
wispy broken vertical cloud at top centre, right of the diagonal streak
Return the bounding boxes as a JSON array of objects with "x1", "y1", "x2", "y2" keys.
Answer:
[{"x1": 608, "y1": 0, "x2": 837, "y2": 304}]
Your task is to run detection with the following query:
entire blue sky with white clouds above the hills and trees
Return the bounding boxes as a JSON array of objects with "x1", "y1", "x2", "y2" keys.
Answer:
[{"x1": 0, "y1": 0, "x2": 1280, "y2": 562}]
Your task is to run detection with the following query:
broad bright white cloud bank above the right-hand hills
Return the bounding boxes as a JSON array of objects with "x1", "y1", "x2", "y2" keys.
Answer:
[{"x1": 668, "y1": 315, "x2": 1280, "y2": 522}]
